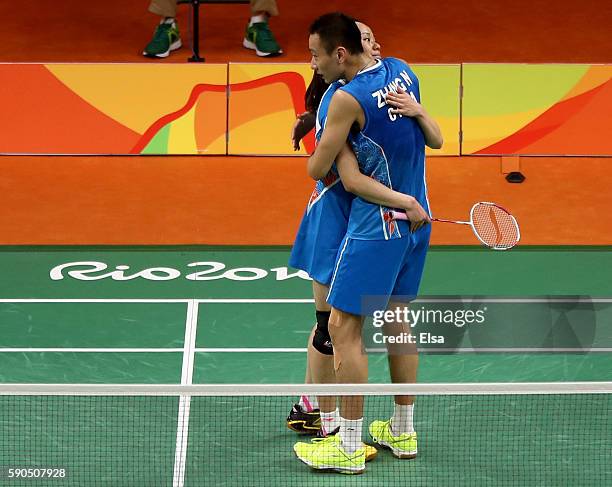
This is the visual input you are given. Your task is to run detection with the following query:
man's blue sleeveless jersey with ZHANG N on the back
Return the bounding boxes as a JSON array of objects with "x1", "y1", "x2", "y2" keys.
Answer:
[{"x1": 340, "y1": 58, "x2": 429, "y2": 240}]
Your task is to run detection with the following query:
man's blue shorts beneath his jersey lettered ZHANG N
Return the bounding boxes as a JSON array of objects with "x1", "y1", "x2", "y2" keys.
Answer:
[{"x1": 327, "y1": 225, "x2": 431, "y2": 316}]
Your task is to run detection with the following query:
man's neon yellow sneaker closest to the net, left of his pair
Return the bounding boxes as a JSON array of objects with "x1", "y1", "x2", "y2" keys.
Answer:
[{"x1": 293, "y1": 435, "x2": 366, "y2": 474}]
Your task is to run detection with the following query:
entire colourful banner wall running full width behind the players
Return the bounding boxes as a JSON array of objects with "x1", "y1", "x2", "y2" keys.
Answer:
[{"x1": 0, "y1": 63, "x2": 612, "y2": 155}]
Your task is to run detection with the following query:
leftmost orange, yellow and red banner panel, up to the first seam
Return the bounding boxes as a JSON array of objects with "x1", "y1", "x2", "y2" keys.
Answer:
[{"x1": 0, "y1": 64, "x2": 227, "y2": 154}]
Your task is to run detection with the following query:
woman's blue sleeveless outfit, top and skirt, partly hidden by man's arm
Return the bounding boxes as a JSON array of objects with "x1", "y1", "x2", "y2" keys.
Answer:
[{"x1": 289, "y1": 81, "x2": 354, "y2": 285}]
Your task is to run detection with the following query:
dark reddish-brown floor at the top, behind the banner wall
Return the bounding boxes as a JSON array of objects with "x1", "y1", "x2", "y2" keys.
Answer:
[{"x1": 0, "y1": 0, "x2": 612, "y2": 63}]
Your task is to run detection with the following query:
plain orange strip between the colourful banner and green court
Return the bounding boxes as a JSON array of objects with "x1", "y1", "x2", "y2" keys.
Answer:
[{"x1": 0, "y1": 156, "x2": 612, "y2": 245}]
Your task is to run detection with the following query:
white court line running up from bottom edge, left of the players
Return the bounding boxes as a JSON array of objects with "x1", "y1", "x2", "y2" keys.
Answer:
[{"x1": 172, "y1": 299, "x2": 198, "y2": 487}]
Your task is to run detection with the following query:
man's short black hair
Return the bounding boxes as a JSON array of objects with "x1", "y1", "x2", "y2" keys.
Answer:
[{"x1": 308, "y1": 12, "x2": 363, "y2": 54}]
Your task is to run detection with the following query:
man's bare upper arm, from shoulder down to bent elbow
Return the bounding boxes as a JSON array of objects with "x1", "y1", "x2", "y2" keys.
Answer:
[{"x1": 308, "y1": 90, "x2": 363, "y2": 179}]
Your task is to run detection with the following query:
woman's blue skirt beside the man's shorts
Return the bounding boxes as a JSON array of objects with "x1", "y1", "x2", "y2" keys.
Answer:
[{"x1": 289, "y1": 182, "x2": 353, "y2": 286}]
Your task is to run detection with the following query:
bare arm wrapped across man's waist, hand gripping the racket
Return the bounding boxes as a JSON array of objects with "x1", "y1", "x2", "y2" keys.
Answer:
[{"x1": 336, "y1": 144, "x2": 431, "y2": 232}]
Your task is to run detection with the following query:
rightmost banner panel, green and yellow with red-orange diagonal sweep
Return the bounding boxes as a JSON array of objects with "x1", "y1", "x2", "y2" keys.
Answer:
[{"x1": 462, "y1": 64, "x2": 612, "y2": 155}]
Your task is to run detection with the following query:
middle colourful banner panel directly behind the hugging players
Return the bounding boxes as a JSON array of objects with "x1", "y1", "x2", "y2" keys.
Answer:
[{"x1": 228, "y1": 64, "x2": 460, "y2": 155}]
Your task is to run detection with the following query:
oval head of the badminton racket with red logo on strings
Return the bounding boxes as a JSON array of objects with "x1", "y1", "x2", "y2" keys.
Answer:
[{"x1": 470, "y1": 201, "x2": 521, "y2": 250}]
